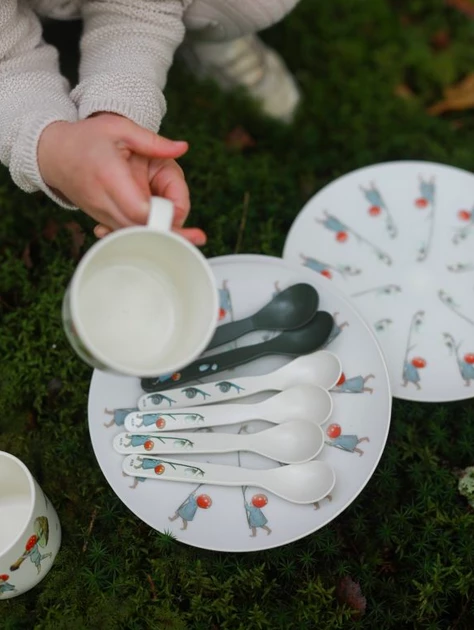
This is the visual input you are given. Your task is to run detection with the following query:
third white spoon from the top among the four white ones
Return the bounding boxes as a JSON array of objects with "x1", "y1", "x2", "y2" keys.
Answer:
[{"x1": 114, "y1": 420, "x2": 324, "y2": 464}]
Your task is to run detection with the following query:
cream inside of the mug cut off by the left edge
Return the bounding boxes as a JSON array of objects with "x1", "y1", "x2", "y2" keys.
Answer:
[{"x1": 0, "y1": 453, "x2": 34, "y2": 556}]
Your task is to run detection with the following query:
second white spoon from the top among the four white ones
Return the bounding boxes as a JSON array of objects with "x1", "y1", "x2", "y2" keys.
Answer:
[{"x1": 124, "y1": 385, "x2": 333, "y2": 433}]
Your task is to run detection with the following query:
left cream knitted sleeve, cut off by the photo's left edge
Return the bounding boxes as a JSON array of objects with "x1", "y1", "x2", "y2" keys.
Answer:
[{"x1": 0, "y1": 0, "x2": 77, "y2": 205}]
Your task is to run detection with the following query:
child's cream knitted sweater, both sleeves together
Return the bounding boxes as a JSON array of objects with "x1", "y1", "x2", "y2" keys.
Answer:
[{"x1": 0, "y1": 0, "x2": 191, "y2": 207}]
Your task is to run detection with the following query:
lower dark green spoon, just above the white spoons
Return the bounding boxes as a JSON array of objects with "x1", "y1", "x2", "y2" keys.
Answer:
[{"x1": 141, "y1": 311, "x2": 334, "y2": 392}]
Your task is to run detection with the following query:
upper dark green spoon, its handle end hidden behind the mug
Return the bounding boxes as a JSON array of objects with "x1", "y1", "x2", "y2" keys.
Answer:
[{"x1": 206, "y1": 283, "x2": 319, "y2": 350}]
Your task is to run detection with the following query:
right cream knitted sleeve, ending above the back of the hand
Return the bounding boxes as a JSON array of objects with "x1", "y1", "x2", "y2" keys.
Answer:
[{"x1": 71, "y1": 0, "x2": 189, "y2": 131}]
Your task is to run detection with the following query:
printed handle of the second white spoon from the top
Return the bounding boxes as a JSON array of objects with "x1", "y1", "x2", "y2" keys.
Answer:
[{"x1": 124, "y1": 404, "x2": 260, "y2": 433}]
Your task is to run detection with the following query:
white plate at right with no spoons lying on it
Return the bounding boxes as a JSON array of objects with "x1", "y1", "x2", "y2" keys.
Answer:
[{"x1": 283, "y1": 162, "x2": 474, "y2": 402}]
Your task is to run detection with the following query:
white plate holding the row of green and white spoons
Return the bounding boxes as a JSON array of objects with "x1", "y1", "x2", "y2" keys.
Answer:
[{"x1": 89, "y1": 255, "x2": 391, "y2": 551}]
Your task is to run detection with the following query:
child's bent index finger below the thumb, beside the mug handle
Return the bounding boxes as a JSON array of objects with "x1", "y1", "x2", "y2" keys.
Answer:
[{"x1": 150, "y1": 160, "x2": 191, "y2": 227}]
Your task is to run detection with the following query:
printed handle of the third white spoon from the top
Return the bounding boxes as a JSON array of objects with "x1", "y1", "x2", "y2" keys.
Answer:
[{"x1": 113, "y1": 432, "x2": 253, "y2": 455}]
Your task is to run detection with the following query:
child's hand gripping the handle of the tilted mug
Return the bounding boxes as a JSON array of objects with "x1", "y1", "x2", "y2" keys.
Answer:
[{"x1": 38, "y1": 113, "x2": 205, "y2": 245}]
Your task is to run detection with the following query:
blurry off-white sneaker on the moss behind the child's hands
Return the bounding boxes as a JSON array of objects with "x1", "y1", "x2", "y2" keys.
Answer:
[{"x1": 180, "y1": 35, "x2": 301, "y2": 123}]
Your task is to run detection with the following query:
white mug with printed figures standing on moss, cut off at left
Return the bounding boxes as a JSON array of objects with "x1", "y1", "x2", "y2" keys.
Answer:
[{"x1": 0, "y1": 451, "x2": 61, "y2": 600}]
